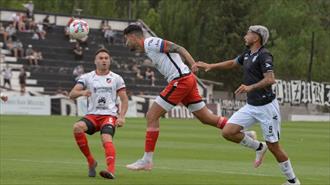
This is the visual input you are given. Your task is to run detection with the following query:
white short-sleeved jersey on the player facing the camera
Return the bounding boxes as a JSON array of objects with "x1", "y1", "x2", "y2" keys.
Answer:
[{"x1": 77, "y1": 71, "x2": 126, "y2": 116}]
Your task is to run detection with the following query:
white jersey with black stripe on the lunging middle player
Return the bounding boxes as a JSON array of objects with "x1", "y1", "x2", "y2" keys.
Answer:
[{"x1": 144, "y1": 37, "x2": 190, "y2": 82}]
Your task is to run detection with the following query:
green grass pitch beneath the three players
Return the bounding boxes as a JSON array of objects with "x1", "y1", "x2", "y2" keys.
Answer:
[{"x1": 0, "y1": 115, "x2": 330, "y2": 185}]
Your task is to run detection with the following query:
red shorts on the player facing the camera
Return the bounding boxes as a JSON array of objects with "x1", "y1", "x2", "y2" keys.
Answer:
[{"x1": 81, "y1": 114, "x2": 117, "y2": 134}]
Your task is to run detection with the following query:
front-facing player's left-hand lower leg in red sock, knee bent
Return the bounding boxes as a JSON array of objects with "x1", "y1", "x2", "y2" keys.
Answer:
[{"x1": 73, "y1": 121, "x2": 97, "y2": 177}]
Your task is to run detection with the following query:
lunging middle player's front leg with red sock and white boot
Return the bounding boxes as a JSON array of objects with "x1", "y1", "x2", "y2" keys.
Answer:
[{"x1": 126, "y1": 102, "x2": 167, "y2": 170}]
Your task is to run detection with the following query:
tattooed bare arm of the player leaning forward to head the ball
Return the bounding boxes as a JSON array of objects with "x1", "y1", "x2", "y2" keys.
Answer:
[{"x1": 164, "y1": 40, "x2": 198, "y2": 72}]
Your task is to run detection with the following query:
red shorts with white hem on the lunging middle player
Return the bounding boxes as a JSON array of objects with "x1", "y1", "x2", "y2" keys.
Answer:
[{"x1": 156, "y1": 73, "x2": 203, "y2": 111}]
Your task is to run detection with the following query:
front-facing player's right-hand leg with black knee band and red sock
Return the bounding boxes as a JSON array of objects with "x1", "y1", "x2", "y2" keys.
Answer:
[{"x1": 100, "y1": 124, "x2": 116, "y2": 179}]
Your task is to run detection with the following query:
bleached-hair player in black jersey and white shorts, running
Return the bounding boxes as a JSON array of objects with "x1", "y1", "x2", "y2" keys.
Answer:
[{"x1": 197, "y1": 25, "x2": 300, "y2": 185}]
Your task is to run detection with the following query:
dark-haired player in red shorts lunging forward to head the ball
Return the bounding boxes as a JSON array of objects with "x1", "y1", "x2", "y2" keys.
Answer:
[{"x1": 124, "y1": 25, "x2": 255, "y2": 170}]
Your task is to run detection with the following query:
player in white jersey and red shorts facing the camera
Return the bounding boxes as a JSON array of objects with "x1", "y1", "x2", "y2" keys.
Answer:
[{"x1": 70, "y1": 48, "x2": 128, "y2": 179}]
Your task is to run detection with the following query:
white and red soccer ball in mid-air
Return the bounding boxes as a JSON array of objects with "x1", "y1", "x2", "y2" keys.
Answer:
[{"x1": 69, "y1": 19, "x2": 89, "y2": 39}]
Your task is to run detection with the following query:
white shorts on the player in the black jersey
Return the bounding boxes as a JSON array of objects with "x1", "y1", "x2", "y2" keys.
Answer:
[{"x1": 228, "y1": 99, "x2": 281, "y2": 143}]
